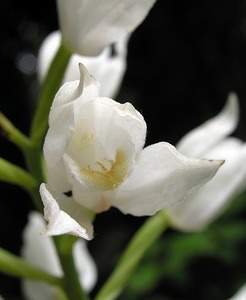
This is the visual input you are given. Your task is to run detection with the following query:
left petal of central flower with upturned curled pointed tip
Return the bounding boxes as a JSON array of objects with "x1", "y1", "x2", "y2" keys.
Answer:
[{"x1": 44, "y1": 64, "x2": 98, "y2": 168}]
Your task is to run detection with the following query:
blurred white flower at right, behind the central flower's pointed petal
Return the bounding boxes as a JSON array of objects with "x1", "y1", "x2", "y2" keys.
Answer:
[{"x1": 167, "y1": 93, "x2": 246, "y2": 230}]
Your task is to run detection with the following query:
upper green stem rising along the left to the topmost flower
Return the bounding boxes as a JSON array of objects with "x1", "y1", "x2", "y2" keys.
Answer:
[{"x1": 31, "y1": 43, "x2": 72, "y2": 146}]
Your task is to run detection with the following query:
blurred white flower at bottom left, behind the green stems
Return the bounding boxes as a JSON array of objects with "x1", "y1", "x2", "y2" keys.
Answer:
[{"x1": 21, "y1": 212, "x2": 97, "y2": 300}]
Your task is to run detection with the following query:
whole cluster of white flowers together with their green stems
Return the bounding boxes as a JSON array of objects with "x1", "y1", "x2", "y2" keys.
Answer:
[{"x1": 0, "y1": 0, "x2": 246, "y2": 300}]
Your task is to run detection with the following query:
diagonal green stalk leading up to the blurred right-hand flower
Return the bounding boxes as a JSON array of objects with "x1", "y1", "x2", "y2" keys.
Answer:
[{"x1": 95, "y1": 211, "x2": 169, "y2": 300}]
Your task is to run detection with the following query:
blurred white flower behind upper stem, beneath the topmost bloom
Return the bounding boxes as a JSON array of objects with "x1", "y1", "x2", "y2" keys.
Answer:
[{"x1": 37, "y1": 31, "x2": 128, "y2": 97}]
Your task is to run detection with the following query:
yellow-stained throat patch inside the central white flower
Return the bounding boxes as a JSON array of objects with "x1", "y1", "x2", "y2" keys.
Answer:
[{"x1": 80, "y1": 150, "x2": 127, "y2": 190}]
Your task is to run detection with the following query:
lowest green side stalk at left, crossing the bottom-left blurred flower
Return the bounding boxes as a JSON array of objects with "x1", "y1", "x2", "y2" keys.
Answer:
[{"x1": 0, "y1": 248, "x2": 62, "y2": 287}]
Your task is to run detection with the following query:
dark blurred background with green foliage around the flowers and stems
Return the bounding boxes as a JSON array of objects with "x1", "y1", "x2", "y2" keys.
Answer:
[{"x1": 0, "y1": 0, "x2": 246, "y2": 300}]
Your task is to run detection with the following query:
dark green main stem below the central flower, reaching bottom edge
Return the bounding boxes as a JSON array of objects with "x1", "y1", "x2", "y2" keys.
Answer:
[{"x1": 54, "y1": 235, "x2": 89, "y2": 300}]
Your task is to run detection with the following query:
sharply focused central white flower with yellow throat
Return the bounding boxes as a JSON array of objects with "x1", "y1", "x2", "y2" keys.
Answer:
[{"x1": 40, "y1": 65, "x2": 223, "y2": 239}]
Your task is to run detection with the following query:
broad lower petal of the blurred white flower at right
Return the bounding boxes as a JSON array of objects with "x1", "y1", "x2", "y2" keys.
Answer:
[{"x1": 167, "y1": 139, "x2": 246, "y2": 231}]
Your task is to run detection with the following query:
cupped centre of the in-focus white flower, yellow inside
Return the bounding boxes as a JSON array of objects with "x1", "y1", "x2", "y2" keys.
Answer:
[{"x1": 63, "y1": 98, "x2": 146, "y2": 212}]
